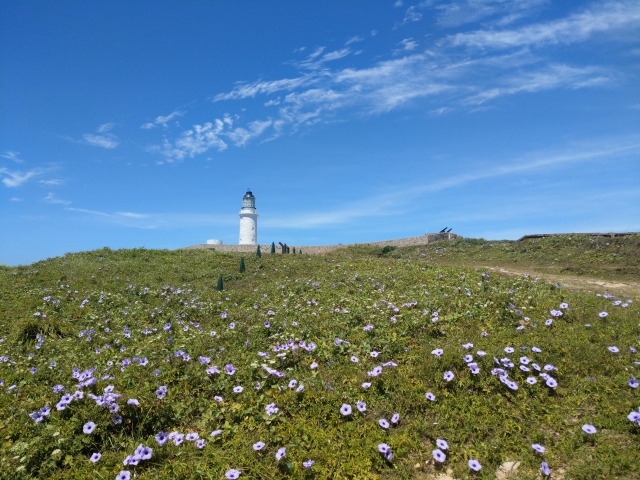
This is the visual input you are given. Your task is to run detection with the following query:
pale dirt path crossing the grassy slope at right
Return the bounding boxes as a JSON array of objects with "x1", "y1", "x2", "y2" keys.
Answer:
[{"x1": 484, "y1": 266, "x2": 640, "y2": 299}]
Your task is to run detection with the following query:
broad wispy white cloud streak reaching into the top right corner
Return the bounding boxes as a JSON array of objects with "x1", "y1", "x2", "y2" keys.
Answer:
[{"x1": 444, "y1": 2, "x2": 640, "y2": 49}]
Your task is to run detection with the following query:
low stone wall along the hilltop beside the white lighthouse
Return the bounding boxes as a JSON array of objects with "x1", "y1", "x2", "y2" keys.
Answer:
[{"x1": 178, "y1": 233, "x2": 460, "y2": 255}]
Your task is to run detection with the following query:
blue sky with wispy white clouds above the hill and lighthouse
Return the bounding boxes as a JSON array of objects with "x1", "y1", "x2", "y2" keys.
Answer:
[{"x1": 0, "y1": 0, "x2": 640, "y2": 265}]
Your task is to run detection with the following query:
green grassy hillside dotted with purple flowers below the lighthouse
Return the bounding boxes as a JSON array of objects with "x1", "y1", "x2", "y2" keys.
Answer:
[{"x1": 0, "y1": 246, "x2": 640, "y2": 479}]
